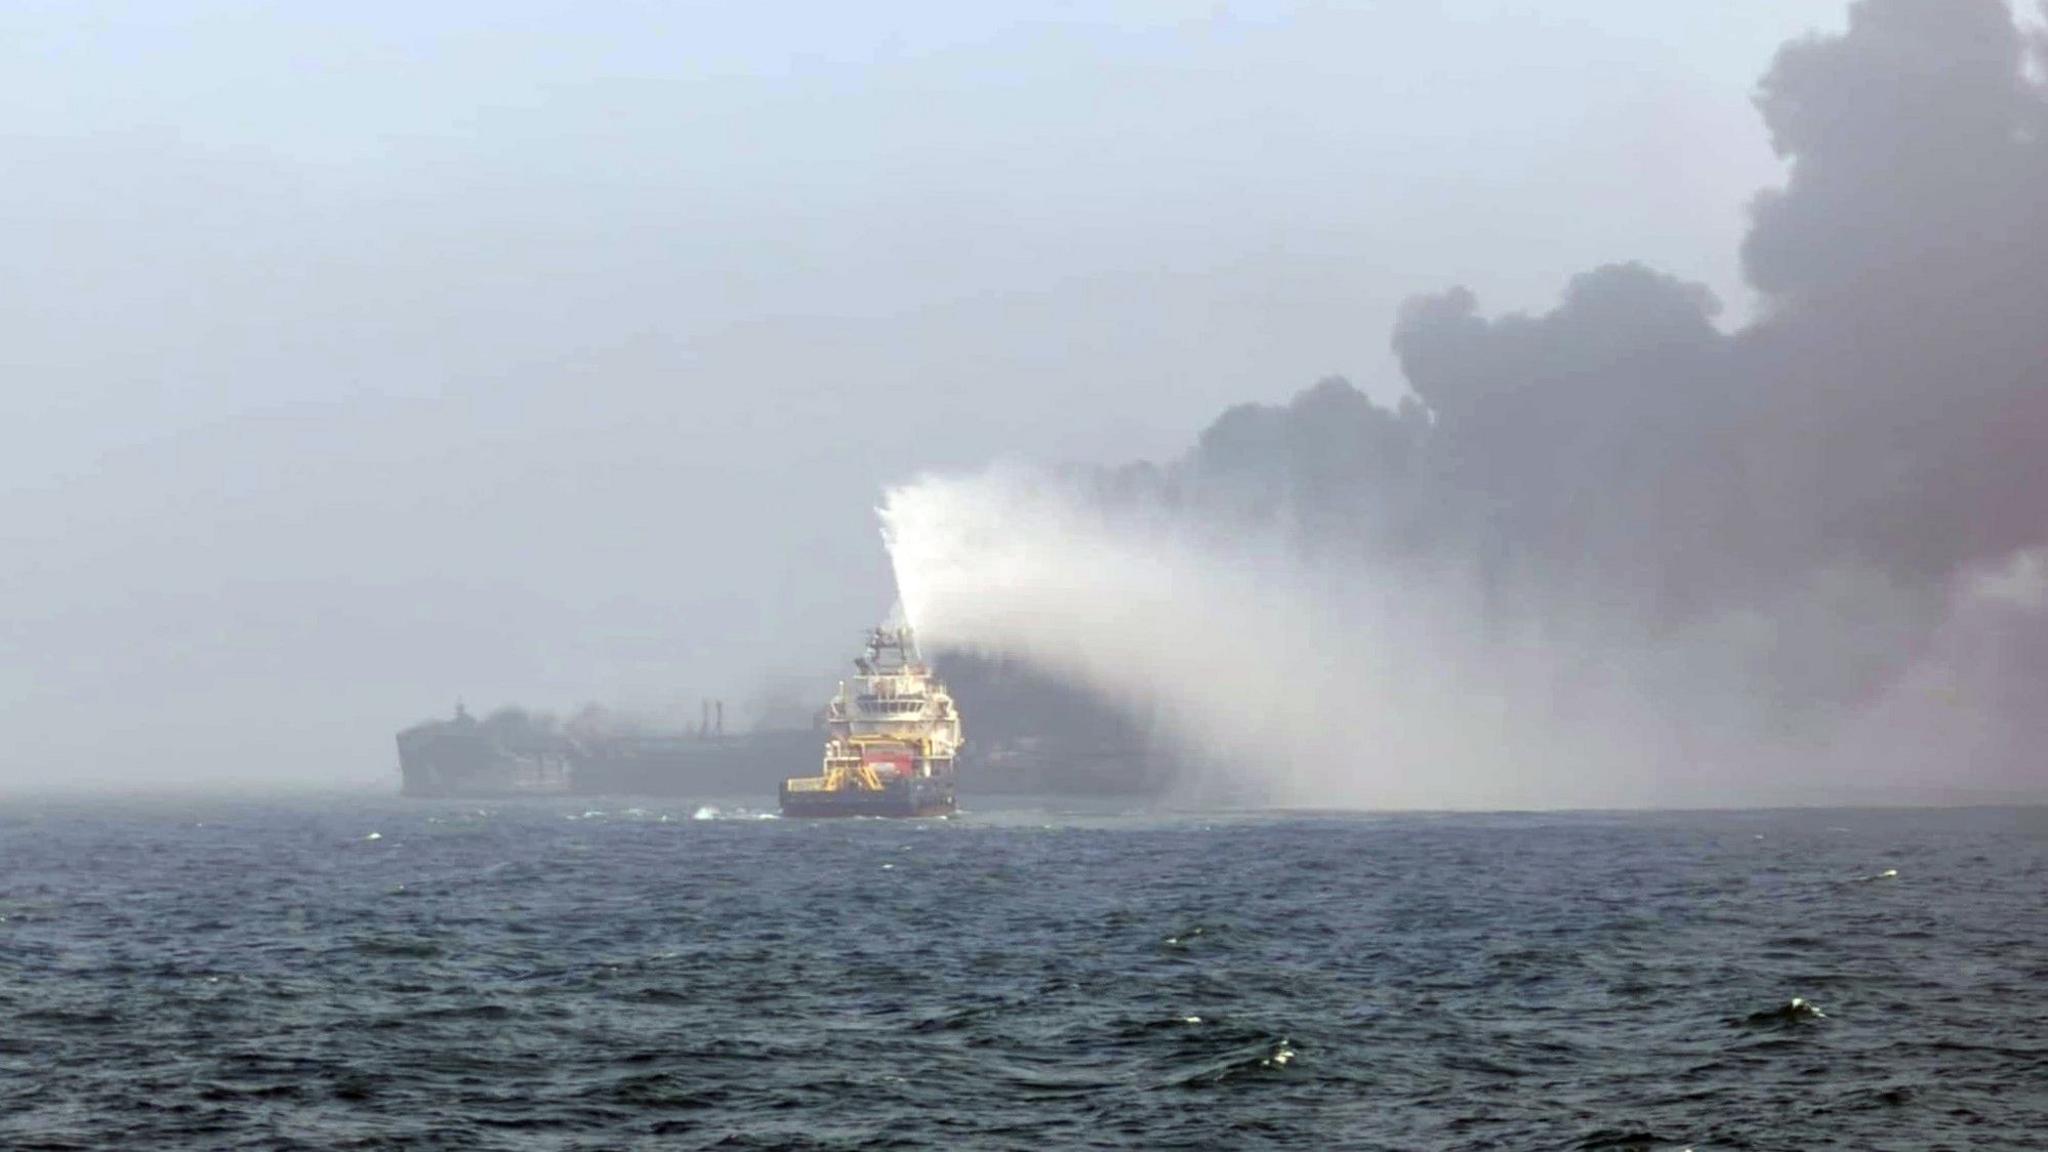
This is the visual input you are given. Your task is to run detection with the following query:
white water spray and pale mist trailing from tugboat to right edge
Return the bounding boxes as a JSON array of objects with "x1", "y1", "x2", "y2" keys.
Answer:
[{"x1": 881, "y1": 467, "x2": 2036, "y2": 808}]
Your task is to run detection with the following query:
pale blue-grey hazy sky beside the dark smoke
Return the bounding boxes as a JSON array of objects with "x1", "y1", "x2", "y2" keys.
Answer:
[{"x1": 0, "y1": 0, "x2": 1841, "y2": 787}]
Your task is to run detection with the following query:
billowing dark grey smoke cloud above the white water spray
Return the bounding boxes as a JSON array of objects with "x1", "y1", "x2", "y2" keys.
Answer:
[{"x1": 1108, "y1": 0, "x2": 2048, "y2": 779}]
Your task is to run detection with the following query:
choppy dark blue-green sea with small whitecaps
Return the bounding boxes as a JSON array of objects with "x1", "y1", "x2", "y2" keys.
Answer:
[{"x1": 0, "y1": 795, "x2": 2048, "y2": 1152}]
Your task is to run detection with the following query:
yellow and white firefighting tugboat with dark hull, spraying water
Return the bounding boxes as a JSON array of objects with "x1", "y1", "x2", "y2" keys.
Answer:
[{"x1": 782, "y1": 627, "x2": 961, "y2": 816}]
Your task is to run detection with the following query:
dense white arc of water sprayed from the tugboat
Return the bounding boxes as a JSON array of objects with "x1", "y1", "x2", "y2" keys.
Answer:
[{"x1": 881, "y1": 467, "x2": 1744, "y2": 808}]
